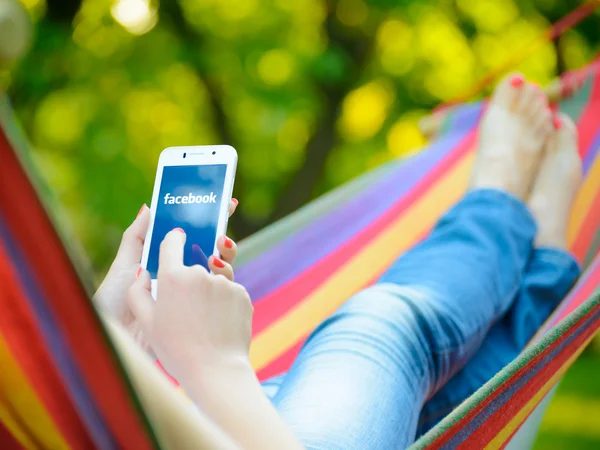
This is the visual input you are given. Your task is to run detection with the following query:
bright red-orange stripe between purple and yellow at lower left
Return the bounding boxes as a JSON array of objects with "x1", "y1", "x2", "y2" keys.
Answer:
[{"x1": 0, "y1": 246, "x2": 93, "y2": 448}]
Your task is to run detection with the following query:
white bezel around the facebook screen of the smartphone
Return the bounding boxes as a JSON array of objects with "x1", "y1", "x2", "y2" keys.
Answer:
[{"x1": 141, "y1": 145, "x2": 237, "y2": 280}]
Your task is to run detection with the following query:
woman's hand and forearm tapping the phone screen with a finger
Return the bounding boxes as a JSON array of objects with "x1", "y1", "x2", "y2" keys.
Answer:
[{"x1": 128, "y1": 230, "x2": 303, "y2": 450}]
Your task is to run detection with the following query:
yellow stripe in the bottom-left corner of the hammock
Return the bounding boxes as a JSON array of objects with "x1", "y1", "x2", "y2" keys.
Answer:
[{"x1": 0, "y1": 334, "x2": 70, "y2": 450}]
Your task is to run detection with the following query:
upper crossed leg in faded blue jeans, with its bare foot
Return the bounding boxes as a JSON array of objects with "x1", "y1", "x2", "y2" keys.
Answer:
[{"x1": 273, "y1": 75, "x2": 545, "y2": 449}]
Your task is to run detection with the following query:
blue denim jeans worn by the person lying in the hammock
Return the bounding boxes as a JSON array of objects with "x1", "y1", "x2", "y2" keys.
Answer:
[{"x1": 264, "y1": 190, "x2": 578, "y2": 449}]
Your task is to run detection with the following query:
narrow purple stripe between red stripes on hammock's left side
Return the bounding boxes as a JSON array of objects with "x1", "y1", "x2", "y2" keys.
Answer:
[{"x1": 0, "y1": 214, "x2": 117, "y2": 449}]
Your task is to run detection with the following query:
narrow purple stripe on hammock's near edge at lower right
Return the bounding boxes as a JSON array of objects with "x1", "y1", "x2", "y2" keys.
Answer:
[{"x1": 440, "y1": 310, "x2": 600, "y2": 450}]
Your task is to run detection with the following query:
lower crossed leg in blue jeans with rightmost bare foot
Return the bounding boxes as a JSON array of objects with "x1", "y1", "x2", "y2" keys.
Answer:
[{"x1": 419, "y1": 116, "x2": 581, "y2": 435}]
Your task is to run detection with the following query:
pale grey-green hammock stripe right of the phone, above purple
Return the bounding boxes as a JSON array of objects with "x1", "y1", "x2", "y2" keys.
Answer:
[{"x1": 236, "y1": 152, "x2": 408, "y2": 266}]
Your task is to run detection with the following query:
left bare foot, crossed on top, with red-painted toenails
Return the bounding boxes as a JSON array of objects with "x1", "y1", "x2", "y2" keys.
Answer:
[{"x1": 471, "y1": 74, "x2": 552, "y2": 200}]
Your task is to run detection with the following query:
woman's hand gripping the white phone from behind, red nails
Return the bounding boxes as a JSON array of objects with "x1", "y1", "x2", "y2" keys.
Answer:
[{"x1": 94, "y1": 199, "x2": 238, "y2": 351}]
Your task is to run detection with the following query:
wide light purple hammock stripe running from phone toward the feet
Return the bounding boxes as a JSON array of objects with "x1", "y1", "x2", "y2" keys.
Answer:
[{"x1": 236, "y1": 104, "x2": 482, "y2": 303}]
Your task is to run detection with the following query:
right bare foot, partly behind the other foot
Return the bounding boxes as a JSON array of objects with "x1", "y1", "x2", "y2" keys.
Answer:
[{"x1": 528, "y1": 114, "x2": 583, "y2": 249}]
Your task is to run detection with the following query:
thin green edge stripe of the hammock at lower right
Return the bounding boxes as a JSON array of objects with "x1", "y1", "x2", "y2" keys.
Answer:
[{"x1": 410, "y1": 291, "x2": 600, "y2": 449}]
